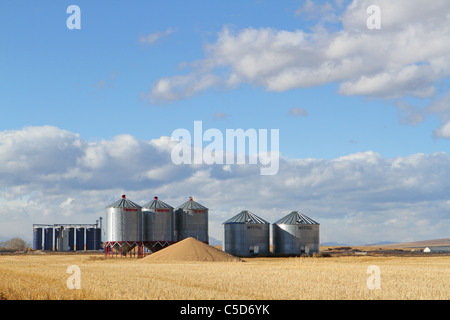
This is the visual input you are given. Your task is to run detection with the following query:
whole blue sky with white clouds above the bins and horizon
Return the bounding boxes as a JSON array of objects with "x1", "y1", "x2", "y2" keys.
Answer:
[{"x1": 0, "y1": 0, "x2": 450, "y2": 244}]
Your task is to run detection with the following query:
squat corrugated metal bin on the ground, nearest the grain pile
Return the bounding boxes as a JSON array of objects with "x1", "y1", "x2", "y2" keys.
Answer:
[{"x1": 223, "y1": 210, "x2": 270, "y2": 257}]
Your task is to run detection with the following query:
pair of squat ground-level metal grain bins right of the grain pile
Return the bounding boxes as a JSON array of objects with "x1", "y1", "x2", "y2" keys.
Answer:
[{"x1": 223, "y1": 210, "x2": 320, "y2": 257}]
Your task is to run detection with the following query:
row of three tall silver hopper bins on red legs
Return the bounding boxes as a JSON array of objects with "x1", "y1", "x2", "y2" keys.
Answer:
[{"x1": 106, "y1": 195, "x2": 209, "y2": 254}]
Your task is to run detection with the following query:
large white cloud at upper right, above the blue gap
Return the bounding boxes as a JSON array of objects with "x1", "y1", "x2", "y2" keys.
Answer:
[{"x1": 146, "y1": 0, "x2": 450, "y2": 137}]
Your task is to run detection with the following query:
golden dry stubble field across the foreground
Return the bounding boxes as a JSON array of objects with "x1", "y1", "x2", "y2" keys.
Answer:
[{"x1": 0, "y1": 255, "x2": 450, "y2": 300}]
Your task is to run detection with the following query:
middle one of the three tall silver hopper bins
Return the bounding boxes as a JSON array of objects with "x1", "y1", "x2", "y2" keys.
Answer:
[{"x1": 142, "y1": 197, "x2": 174, "y2": 242}]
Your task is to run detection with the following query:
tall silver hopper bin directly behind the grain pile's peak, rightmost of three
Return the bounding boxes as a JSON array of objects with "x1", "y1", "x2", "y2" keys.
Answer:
[{"x1": 174, "y1": 197, "x2": 209, "y2": 243}]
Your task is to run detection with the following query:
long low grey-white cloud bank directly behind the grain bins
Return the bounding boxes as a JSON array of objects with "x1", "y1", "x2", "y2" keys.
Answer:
[{"x1": 0, "y1": 127, "x2": 450, "y2": 242}]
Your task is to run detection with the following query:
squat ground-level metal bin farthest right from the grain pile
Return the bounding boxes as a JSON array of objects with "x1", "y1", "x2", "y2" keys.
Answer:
[{"x1": 272, "y1": 211, "x2": 320, "y2": 255}]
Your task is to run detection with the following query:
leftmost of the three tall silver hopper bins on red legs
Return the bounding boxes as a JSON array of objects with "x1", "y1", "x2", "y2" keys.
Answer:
[{"x1": 105, "y1": 195, "x2": 142, "y2": 254}]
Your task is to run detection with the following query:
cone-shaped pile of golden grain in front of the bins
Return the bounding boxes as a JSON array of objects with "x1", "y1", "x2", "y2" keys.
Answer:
[{"x1": 142, "y1": 237, "x2": 240, "y2": 262}]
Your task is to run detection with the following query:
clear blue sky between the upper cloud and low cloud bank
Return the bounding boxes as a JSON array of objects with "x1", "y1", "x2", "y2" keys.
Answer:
[{"x1": 0, "y1": 1, "x2": 448, "y2": 158}]
